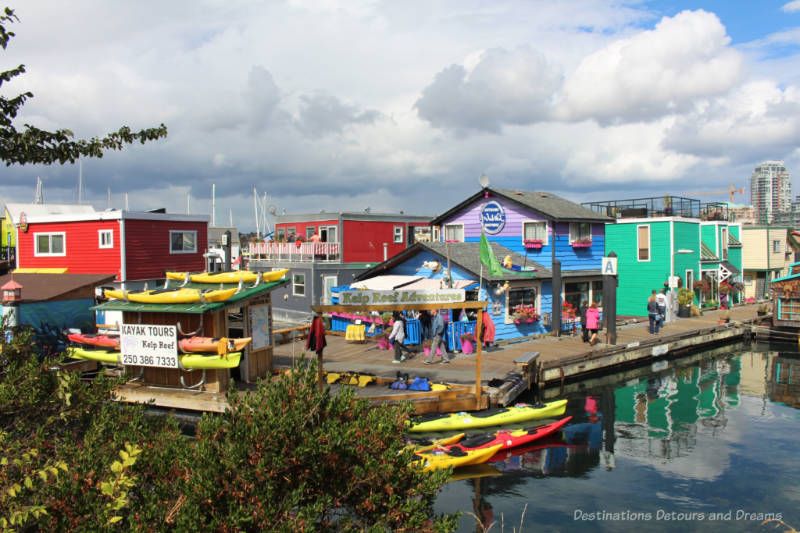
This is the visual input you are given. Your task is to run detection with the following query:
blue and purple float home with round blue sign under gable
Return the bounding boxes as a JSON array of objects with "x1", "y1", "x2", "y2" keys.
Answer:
[{"x1": 346, "y1": 187, "x2": 613, "y2": 340}]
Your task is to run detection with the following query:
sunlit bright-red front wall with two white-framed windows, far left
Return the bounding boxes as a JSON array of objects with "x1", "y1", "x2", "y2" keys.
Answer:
[{"x1": 17, "y1": 220, "x2": 120, "y2": 279}]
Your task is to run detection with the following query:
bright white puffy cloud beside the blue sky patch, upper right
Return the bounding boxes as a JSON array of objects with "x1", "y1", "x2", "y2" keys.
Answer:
[{"x1": 558, "y1": 11, "x2": 743, "y2": 122}]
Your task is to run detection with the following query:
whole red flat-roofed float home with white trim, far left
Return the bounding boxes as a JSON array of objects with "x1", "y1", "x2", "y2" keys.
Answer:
[{"x1": 7, "y1": 204, "x2": 209, "y2": 283}]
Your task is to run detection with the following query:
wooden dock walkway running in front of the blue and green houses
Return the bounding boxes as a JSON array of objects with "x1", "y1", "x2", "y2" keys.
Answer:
[{"x1": 273, "y1": 304, "x2": 758, "y2": 404}]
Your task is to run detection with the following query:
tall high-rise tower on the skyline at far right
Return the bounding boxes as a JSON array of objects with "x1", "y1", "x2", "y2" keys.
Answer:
[{"x1": 750, "y1": 161, "x2": 792, "y2": 222}]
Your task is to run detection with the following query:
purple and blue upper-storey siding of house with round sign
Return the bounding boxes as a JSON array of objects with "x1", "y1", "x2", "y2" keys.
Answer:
[{"x1": 442, "y1": 197, "x2": 605, "y2": 270}]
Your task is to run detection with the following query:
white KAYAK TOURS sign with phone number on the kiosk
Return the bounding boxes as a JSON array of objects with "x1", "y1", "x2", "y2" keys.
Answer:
[{"x1": 119, "y1": 324, "x2": 179, "y2": 368}]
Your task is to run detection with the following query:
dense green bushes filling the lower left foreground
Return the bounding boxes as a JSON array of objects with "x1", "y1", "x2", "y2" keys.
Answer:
[{"x1": 0, "y1": 322, "x2": 456, "y2": 532}]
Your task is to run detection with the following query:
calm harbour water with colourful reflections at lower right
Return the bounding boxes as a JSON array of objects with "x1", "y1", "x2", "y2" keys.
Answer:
[{"x1": 435, "y1": 345, "x2": 800, "y2": 533}]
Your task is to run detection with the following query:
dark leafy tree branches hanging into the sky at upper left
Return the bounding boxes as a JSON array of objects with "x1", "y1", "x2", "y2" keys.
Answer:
[{"x1": 0, "y1": 7, "x2": 167, "y2": 165}]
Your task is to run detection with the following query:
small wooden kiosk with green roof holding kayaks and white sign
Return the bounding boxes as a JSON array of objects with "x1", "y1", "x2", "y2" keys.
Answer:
[{"x1": 95, "y1": 279, "x2": 289, "y2": 411}]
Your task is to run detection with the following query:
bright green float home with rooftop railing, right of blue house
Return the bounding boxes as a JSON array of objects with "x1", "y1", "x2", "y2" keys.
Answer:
[{"x1": 584, "y1": 196, "x2": 742, "y2": 316}]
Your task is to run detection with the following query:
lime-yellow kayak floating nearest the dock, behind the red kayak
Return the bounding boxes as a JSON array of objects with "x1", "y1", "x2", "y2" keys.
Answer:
[{"x1": 408, "y1": 400, "x2": 567, "y2": 432}]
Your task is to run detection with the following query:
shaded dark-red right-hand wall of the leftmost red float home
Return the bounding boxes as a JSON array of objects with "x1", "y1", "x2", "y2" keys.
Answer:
[{"x1": 125, "y1": 218, "x2": 208, "y2": 280}]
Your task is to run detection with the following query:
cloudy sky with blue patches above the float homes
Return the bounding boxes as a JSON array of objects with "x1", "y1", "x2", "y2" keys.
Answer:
[{"x1": 0, "y1": 0, "x2": 800, "y2": 231}]
